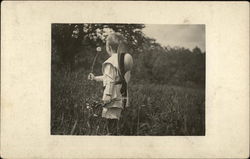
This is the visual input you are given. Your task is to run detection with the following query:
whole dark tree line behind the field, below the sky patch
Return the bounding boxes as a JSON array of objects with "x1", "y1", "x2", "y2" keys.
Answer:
[{"x1": 52, "y1": 24, "x2": 205, "y2": 88}]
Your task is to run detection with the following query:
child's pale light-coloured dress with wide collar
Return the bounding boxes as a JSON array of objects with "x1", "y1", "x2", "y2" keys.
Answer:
[{"x1": 96, "y1": 54, "x2": 130, "y2": 119}]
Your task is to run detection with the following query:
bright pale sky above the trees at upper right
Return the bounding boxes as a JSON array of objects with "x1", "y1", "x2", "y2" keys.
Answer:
[{"x1": 143, "y1": 24, "x2": 205, "y2": 51}]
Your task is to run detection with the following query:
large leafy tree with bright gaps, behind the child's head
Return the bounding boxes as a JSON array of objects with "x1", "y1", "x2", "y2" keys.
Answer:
[{"x1": 52, "y1": 24, "x2": 145, "y2": 68}]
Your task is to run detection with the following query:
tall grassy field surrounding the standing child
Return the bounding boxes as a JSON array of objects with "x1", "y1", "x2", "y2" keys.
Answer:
[{"x1": 51, "y1": 67, "x2": 205, "y2": 136}]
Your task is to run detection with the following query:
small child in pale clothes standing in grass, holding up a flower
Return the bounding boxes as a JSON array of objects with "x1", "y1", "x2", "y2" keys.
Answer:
[{"x1": 88, "y1": 33, "x2": 133, "y2": 135}]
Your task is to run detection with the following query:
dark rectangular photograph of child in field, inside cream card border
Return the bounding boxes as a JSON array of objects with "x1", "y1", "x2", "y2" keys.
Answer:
[{"x1": 50, "y1": 23, "x2": 206, "y2": 136}]
